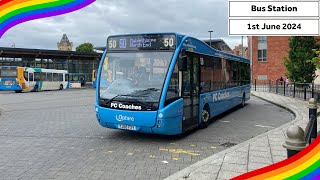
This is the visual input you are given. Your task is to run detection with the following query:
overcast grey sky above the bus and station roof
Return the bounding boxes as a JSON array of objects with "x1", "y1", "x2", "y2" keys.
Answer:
[{"x1": 0, "y1": 0, "x2": 247, "y2": 49}]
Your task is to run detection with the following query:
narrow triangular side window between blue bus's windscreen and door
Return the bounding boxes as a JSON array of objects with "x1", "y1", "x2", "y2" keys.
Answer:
[{"x1": 165, "y1": 60, "x2": 180, "y2": 106}]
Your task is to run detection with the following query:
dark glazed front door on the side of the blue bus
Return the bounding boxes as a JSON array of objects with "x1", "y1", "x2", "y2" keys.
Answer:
[{"x1": 182, "y1": 53, "x2": 200, "y2": 131}]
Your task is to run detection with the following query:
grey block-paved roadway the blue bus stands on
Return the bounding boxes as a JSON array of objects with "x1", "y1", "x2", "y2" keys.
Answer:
[{"x1": 0, "y1": 89, "x2": 293, "y2": 179}]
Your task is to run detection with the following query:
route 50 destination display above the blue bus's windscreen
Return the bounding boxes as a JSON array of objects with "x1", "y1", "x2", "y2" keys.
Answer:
[{"x1": 108, "y1": 34, "x2": 176, "y2": 51}]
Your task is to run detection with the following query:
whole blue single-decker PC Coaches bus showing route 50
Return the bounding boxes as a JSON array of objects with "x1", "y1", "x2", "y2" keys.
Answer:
[{"x1": 95, "y1": 33, "x2": 250, "y2": 135}]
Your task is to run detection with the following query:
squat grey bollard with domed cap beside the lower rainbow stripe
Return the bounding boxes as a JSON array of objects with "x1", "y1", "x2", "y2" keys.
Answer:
[{"x1": 283, "y1": 126, "x2": 307, "y2": 158}]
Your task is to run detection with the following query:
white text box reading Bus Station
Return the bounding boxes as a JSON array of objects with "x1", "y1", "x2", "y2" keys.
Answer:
[{"x1": 229, "y1": 1, "x2": 319, "y2": 17}]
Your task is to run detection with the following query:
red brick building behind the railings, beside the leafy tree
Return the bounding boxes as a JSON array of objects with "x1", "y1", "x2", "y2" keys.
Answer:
[{"x1": 247, "y1": 36, "x2": 289, "y2": 81}]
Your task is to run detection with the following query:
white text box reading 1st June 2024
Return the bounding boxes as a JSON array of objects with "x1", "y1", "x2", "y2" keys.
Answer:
[{"x1": 229, "y1": 19, "x2": 319, "y2": 36}]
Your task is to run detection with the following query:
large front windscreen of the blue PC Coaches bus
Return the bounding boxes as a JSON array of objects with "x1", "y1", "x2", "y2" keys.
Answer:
[{"x1": 100, "y1": 52, "x2": 173, "y2": 102}]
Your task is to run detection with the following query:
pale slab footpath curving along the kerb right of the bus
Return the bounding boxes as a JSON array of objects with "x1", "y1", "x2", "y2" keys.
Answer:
[{"x1": 167, "y1": 92, "x2": 320, "y2": 180}]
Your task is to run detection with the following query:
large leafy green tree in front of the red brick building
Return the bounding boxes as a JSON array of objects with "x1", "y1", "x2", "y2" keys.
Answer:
[{"x1": 284, "y1": 36, "x2": 317, "y2": 83}]
